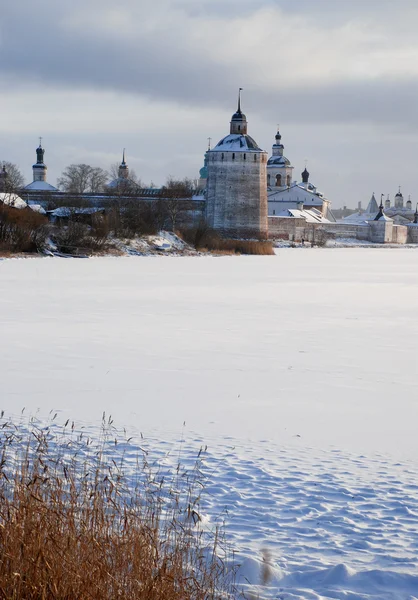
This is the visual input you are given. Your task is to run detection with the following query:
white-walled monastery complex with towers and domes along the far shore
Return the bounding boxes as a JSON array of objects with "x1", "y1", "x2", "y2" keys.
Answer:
[{"x1": 0, "y1": 89, "x2": 418, "y2": 244}]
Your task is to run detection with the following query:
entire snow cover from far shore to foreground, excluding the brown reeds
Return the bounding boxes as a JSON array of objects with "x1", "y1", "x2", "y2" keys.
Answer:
[{"x1": 0, "y1": 248, "x2": 418, "y2": 600}]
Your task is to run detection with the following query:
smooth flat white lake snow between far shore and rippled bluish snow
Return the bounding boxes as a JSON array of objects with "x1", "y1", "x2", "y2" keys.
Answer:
[{"x1": 0, "y1": 249, "x2": 418, "y2": 456}]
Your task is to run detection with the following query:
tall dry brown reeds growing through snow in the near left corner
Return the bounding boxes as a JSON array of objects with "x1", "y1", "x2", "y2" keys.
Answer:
[{"x1": 0, "y1": 421, "x2": 233, "y2": 600}]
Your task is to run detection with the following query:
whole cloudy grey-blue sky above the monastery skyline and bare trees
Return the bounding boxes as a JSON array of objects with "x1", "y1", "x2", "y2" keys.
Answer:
[{"x1": 0, "y1": 0, "x2": 418, "y2": 207}]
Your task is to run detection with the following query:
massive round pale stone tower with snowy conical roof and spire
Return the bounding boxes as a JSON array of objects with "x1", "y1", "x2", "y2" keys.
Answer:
[{"x1": 206, "y1": 90, "x2": 268, "y2": 239}]
